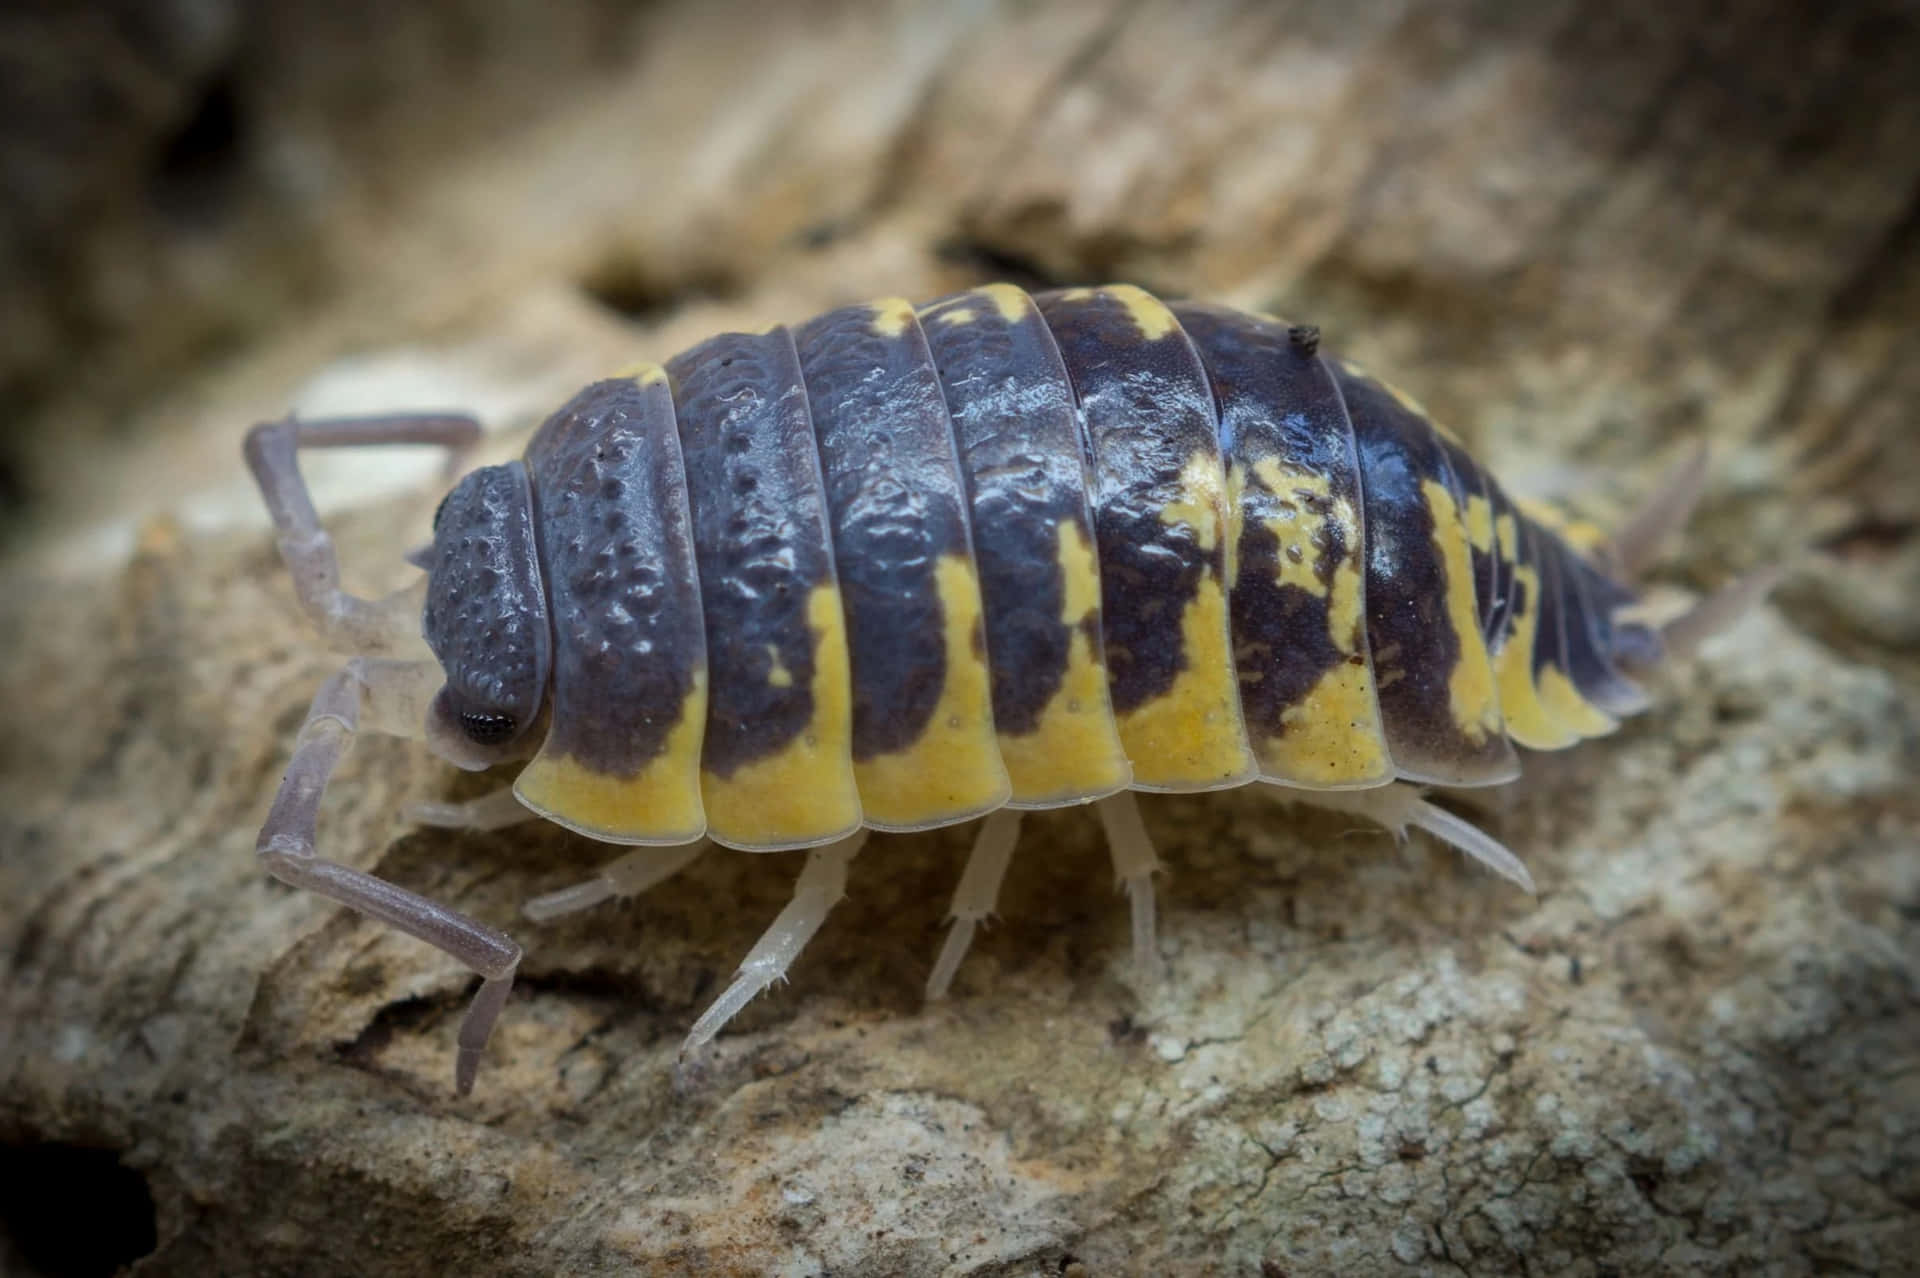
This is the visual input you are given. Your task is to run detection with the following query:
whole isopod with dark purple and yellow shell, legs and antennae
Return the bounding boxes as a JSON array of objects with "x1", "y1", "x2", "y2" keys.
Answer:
[{"x1": 248, "y1": 284, "x2": 1753, "y2": 1092}]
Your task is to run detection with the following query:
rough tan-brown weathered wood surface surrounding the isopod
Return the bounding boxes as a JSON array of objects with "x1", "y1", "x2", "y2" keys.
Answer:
[{"x1": 0, "y1": 0, "x2": 1920, "y2": 1276}]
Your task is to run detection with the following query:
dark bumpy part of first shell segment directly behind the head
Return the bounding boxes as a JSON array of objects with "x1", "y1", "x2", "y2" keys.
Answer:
[{"x1": 526, "y1": 374, "x2": 707, "y2": 775}]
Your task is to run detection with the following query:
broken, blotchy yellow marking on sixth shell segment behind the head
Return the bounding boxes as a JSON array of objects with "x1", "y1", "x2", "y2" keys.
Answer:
[{"x1": 1254, "y1": 457, "x2": 1394, "y2": 789}]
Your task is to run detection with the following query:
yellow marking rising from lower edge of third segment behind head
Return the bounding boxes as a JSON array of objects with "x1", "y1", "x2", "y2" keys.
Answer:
[{"x1": 852, "y1": 555, "x2": 1010, "y2": 829}]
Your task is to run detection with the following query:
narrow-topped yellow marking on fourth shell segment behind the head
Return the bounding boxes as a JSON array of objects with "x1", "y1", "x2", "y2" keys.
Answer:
[{"x1": 1000, "y1": 520, "x2": 1133, "y2": 806}]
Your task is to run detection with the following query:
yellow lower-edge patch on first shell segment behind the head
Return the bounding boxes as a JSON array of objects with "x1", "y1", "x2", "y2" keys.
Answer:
[{"x1": 513, "y1": 670, "x2": 707, "y2": 844}]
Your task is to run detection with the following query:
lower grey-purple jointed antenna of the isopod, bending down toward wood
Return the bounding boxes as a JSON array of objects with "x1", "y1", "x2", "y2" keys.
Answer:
[{"x1": 255, "y1": 662, "x2": 520, "y2": 1096}]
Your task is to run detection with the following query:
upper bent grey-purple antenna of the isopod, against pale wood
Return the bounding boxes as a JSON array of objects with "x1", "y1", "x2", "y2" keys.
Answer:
[{"x1": 246, "y1": 414, "x2": 480, "y2": 654}]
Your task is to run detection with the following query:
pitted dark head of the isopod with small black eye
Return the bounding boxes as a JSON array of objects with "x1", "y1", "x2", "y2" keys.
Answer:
[{"x1": 422, "y1": 461, "x2": 553, "y2": 745}]
